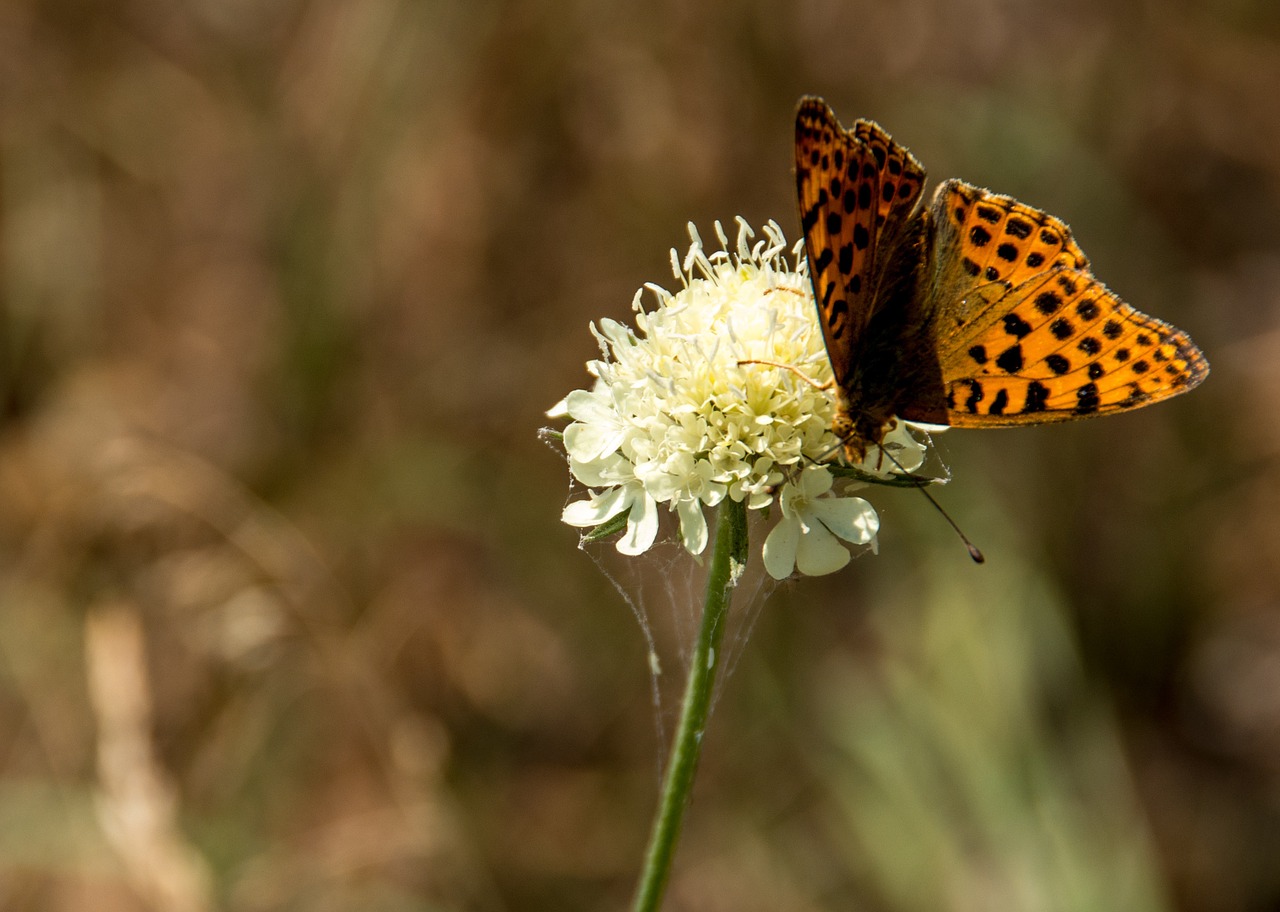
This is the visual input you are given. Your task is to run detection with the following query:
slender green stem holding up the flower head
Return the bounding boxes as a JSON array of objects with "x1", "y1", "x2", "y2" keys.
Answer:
[{"x1": 631, "y1": 498, "x2": 746, "y2": 912}]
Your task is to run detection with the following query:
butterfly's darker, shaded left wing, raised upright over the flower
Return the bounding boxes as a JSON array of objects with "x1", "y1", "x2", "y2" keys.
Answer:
[{"x1": 796, "y1": 97, "x2": 924, "y2": 388}]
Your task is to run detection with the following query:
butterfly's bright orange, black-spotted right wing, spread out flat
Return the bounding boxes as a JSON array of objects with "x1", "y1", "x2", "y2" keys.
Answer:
[{"x1": 921, "y1": 181, "x2": 1208, "y2": 427}]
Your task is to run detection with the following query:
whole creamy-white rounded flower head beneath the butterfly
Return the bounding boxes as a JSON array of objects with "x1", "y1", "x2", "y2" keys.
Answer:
[{"x1": 548, "y1": 219, "x2": 942, "y2": 578}]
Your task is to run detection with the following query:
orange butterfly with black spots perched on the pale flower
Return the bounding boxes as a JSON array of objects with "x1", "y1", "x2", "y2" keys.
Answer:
[{"x1": 796, "y1": 97, "x2": 1208, "y2": 461}]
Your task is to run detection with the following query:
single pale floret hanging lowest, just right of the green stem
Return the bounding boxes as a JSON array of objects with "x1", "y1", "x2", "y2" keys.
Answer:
[{"x1": 764, "y1": 466, "x2": 879, "y2": 579}]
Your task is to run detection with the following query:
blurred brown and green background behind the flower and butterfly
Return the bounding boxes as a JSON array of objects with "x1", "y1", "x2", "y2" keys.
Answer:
[{"x1": 0, "y1": 0, "x2": 1280, "y2": 912}]
